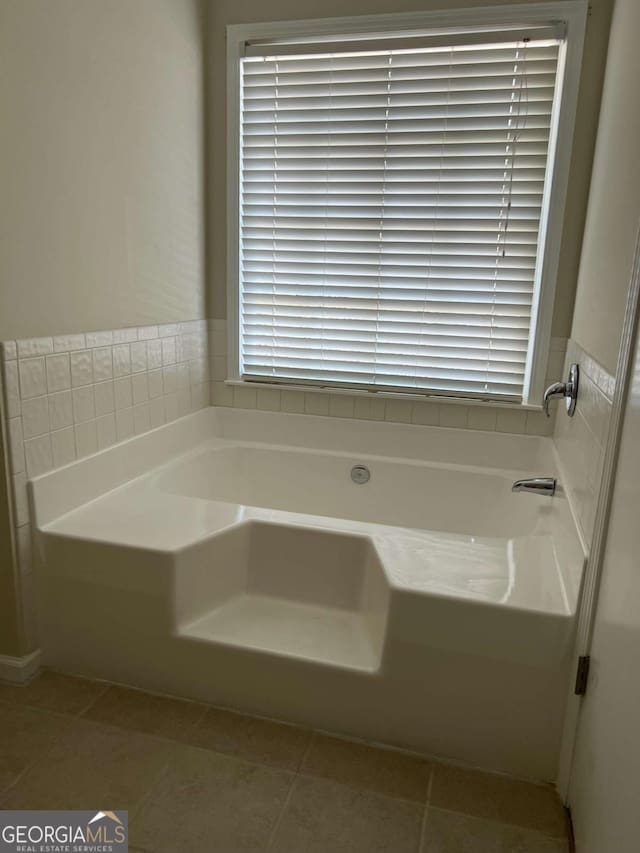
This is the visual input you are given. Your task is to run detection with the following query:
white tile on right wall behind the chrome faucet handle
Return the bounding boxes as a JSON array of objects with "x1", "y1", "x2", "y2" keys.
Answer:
[{"x1": 553, "y1": 340, "x2": 615, "y2": 547}]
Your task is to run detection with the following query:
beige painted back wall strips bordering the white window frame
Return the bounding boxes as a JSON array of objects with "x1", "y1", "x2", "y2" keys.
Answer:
[{"x1": 207, "y1": 0, "x2": 613, "y2": 330}]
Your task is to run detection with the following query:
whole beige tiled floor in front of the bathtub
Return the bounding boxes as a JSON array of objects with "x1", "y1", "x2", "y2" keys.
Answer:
[{"x1": 0, "y1": 671, "x2": 569, "y2": 853}]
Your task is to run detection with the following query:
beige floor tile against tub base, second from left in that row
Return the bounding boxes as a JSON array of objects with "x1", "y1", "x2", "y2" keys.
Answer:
[{"x1": 83, "y1": 686, "x2": 206, "y2": 740}]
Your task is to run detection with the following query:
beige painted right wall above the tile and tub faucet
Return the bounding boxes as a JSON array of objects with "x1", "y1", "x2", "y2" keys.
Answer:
[{"x1": 572, "y1": 0, "x2": 640, "y2": 373}]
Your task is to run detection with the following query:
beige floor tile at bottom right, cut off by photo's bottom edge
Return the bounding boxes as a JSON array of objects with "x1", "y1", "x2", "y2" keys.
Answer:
[{"x1": 420, "y1": 809, "x2": 569, "y2": 853}]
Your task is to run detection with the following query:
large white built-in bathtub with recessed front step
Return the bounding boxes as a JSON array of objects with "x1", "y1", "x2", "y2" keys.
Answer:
[{"x1": 31, "y1": 408, "x2": 584, "y2": 781}]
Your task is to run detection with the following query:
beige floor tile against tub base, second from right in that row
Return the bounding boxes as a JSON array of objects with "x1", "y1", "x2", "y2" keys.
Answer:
[{"x1": 301, "y1": 734, "x2": 432, "y2": 803}]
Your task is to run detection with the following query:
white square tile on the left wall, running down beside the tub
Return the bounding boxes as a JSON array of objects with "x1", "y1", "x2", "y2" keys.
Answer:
[{"x1": 2, "y1": 320, "x2": 210, "y2": 651}]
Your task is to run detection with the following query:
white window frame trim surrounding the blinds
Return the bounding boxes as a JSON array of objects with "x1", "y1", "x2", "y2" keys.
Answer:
[{"x1": 226, "y1": 0, "x2": 588, "y2": 410}]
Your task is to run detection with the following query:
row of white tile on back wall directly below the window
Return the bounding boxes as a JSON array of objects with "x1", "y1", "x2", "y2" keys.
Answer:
[{"x1": 211, "y1": 320, "x2": 566, "y2": 435}]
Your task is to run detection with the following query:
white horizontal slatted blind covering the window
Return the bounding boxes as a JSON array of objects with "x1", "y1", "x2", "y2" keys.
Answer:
[{"x1": 239, "y1": 26, "x2": 561, "y2": 400}]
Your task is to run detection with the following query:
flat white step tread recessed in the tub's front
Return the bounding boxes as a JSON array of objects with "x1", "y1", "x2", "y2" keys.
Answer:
[{"x1": 180, "y1": 594, "x2": 380, "y2": 672}]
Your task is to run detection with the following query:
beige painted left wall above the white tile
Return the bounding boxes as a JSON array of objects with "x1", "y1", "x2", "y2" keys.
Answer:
[{"x1": 0, "y1": 0, "x2": 205, "y2": 339}]
